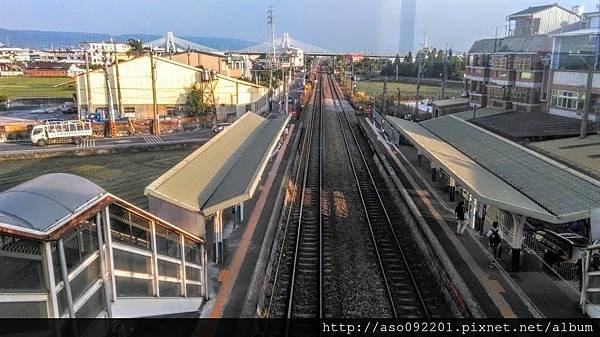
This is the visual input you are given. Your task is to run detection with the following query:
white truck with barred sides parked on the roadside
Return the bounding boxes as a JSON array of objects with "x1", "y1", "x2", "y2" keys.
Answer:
[{"x1": 31, "y1": 121, "x2": 92, "y2": 146}]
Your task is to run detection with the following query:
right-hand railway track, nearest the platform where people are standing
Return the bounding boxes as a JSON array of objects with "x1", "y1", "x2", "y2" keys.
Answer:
[{"x1": 325, "y1": 69, "x2": 431, "y2": 318}]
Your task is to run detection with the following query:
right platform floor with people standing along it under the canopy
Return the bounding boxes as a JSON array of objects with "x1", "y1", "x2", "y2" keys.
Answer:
[{"x1": 367, "y1": 122, "x2": 584, "y2": 318}]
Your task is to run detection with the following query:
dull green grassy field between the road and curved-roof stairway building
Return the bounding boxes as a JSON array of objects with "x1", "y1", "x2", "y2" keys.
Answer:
[{"x1": 0, "y1": 149, "x2": 193, "y2": 209}]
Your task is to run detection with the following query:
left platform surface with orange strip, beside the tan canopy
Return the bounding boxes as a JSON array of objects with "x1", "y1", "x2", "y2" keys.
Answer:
[{"x1": 202, "y1": 119, "x2": 297, "y2": 318}]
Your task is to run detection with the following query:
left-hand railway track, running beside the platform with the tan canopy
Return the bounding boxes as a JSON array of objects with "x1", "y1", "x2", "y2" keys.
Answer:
[{"x1": 266, "y1": 65, "x2": 323, "y2": 318}]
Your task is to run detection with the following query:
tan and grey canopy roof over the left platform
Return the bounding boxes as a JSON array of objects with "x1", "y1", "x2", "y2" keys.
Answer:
[{"x1": 145, "y1": 112, "x2": 289, "y2": 215}]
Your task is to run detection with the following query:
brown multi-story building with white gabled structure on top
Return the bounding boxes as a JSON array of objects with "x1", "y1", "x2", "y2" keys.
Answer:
[{"x1": 464, "y1": 4, "x2": 580, "y2": 111}]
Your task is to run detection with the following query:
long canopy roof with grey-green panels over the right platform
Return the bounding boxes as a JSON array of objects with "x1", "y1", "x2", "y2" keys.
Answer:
[{"x1": 387, "y1": 116, "x2": 600, "y2": 223}]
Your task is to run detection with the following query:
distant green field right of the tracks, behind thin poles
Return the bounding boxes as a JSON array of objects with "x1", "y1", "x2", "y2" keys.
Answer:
[{"x1": 357, "y1": 81, "x2": 461, "y2": 97}]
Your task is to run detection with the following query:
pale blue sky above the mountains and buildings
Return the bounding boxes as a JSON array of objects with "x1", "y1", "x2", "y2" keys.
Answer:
[{"x1": 0, "y1": 0, "x2": 597, "y2": 53}]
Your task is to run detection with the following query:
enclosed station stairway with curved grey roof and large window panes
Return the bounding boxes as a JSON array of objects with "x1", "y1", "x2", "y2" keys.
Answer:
[{"x1": 0, "y1": 174, "x2": 207, "y2": 318}]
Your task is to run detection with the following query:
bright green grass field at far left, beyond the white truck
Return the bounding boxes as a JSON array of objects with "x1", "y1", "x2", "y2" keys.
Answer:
[{"x1": 0, "y1": 77, "x2": 75, "y2": 98}]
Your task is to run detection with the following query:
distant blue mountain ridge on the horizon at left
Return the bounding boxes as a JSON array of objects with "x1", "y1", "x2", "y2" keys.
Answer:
[{"x1": 0, "y1": 28, "x2": 255, "y2": 51}]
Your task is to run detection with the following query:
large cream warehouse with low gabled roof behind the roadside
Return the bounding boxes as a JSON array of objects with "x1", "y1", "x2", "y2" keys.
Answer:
[{"x1": 76, "y1": 55, "x2": 268, "y2": 120}]
